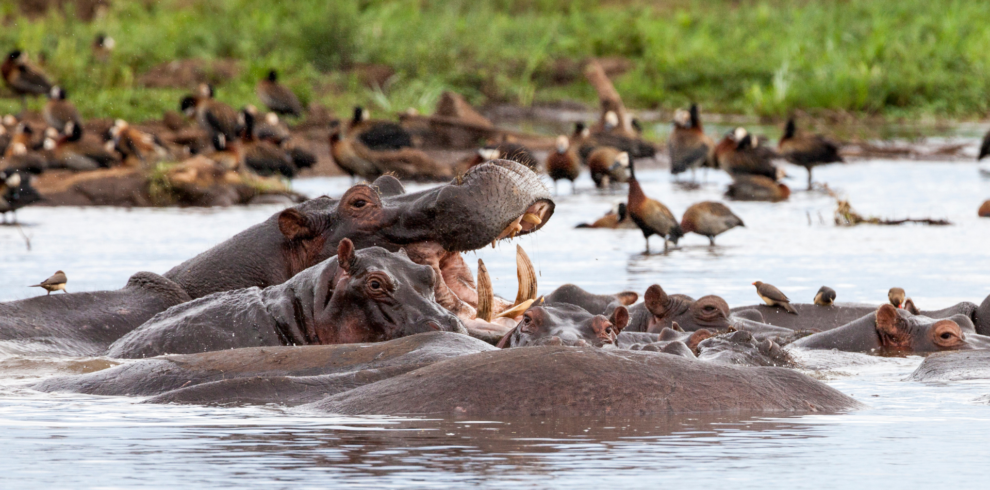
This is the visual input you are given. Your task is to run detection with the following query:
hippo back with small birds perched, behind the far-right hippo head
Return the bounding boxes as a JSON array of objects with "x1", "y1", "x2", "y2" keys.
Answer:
[{"x1": 732, "y1": 296, "x2": 990, "y2": 335}]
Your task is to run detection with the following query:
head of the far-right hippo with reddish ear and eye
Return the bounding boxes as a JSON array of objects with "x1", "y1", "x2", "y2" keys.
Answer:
[{"x1": 876, "y1": 304, "x2": 990, "y2": 354}]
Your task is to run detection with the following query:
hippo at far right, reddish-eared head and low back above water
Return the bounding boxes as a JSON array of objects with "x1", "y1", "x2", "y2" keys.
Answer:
[{"x1": 790, "y1": 304, "x2": 990, "y2": 355}]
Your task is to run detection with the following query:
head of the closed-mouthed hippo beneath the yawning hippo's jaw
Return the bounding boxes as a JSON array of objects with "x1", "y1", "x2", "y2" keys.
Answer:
[{"x1": 315, "y1": 238, "x2": 464, "y2": 344}]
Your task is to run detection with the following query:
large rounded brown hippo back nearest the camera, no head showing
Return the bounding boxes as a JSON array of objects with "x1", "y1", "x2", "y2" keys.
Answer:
[{"x1": 307, "y1": 346, "x2": 861, "y2": 417}]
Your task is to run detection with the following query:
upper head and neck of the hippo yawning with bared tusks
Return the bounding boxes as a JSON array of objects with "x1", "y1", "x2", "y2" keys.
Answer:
[{"x1": 166, "y1": 160, "x2": 554, "y2": 298}]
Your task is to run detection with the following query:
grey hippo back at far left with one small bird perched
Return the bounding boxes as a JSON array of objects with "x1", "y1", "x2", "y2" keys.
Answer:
[{"x1": 0, "y1": 272, "x2": 190, "y2": 356}]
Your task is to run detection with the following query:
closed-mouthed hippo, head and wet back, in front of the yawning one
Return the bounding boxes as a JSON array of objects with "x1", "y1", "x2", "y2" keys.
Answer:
[{"x1": 107, "y1": 238, "x2": 467, "y2": 358}]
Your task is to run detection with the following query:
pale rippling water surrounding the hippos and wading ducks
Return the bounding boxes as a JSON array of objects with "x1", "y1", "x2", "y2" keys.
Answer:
[{"x1": 0, "y1": 161, "x2": 990, "y2": 488}]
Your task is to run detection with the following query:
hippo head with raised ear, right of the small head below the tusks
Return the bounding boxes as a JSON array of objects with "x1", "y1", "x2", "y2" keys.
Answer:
[{"x1": 643, "y1": 284, "x2": 732, "y2": 333}]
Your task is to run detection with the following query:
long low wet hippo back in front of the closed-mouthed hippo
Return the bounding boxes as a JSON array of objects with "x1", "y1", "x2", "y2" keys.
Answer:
[{"x1": 34, "y1": 332, "x2": 495, "y2": 405}]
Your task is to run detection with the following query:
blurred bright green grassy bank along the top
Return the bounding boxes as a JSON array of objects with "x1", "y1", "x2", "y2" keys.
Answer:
[{"x1": 0, "y1": 0, "x2": 990, "y2": 124}]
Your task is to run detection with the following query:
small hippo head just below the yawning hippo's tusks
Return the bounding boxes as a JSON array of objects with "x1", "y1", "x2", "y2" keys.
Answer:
[{"x1": 500, "y1": 303, "x2": 629, "y2": 347}]
